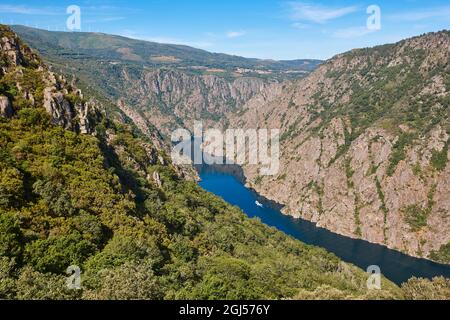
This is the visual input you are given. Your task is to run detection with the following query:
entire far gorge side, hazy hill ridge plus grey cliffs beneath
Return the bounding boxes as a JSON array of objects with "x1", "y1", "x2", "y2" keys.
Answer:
[{"x1": 14, "y1": 26, "x2": 321, "y2": 136}]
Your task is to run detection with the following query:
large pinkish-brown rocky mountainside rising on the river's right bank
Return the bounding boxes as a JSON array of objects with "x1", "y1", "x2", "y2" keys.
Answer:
[{"x1": 230, "y1": 32, "x2": 450, "y2": 263}]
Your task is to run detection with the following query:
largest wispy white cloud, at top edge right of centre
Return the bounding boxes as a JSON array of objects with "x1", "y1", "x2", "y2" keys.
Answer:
[{"x1": 290, "y1": 2, "x2": 358, "y2": 23}]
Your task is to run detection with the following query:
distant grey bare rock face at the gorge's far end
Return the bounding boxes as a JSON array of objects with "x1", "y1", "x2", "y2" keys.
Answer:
[{"x1": 109, "y1": 67, "x2": 275, "y2": 136}]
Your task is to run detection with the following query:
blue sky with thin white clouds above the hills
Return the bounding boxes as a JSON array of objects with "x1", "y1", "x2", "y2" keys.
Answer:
[{"x1": 0, "y1": 0, "x2": 450, "y2": 59}]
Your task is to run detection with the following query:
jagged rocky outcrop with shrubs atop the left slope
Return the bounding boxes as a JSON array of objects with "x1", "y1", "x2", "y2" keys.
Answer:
[{"x1": 0, "y1": 26, "x2": 98, "y2": 134}]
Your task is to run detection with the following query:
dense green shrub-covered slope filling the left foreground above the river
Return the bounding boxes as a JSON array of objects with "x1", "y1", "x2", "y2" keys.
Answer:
[{"x1": 0, "y1": 108, "x2": 408, "y2": 299}]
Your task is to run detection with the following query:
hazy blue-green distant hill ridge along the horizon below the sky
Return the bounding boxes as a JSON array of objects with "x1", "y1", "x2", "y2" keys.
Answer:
[{"x1": 13, "y1": 26, "x2": 321, "y2": 78}]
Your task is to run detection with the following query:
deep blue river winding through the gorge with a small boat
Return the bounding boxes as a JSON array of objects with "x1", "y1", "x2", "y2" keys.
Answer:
[{"x1": 199, "y1": 170, "x2": 450, "y2": 285}]
